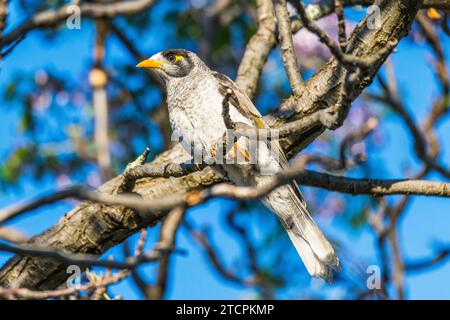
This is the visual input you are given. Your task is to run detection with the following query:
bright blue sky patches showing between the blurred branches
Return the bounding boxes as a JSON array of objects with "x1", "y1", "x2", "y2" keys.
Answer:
[{"x1": 0, "y1": 1, "x2": 450, "y2": 299}]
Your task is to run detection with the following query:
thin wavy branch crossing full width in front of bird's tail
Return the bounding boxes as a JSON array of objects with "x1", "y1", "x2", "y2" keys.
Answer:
[{"x1": 2, "y1": 159, "x2": 450, "y2": 230}]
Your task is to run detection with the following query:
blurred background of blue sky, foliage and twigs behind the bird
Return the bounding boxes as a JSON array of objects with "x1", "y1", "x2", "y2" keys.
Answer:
[{"x1": 0, "y1": 0, "x2": 450, "y2": 299}]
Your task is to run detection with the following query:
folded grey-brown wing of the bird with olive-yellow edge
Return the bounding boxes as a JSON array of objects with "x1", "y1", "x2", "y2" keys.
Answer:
[{"x1": 213, "y1": 72, "x2": 306, "y2": 209}]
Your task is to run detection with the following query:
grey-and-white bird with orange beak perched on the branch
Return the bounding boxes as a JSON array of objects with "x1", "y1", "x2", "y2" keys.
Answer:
[{"x1": 137, "y1": 49, "x2": 340, "y2": 282}]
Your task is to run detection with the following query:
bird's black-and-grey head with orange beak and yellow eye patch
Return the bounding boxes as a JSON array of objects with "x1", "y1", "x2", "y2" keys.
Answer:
[{"x1": 136, "y1": 49, "x2": 200, "y2": 81}]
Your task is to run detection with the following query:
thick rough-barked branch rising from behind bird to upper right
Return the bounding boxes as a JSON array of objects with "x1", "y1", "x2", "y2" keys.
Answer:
[{"x1": 265, "y1": 0, "x2": 420, "y2": 157}]
